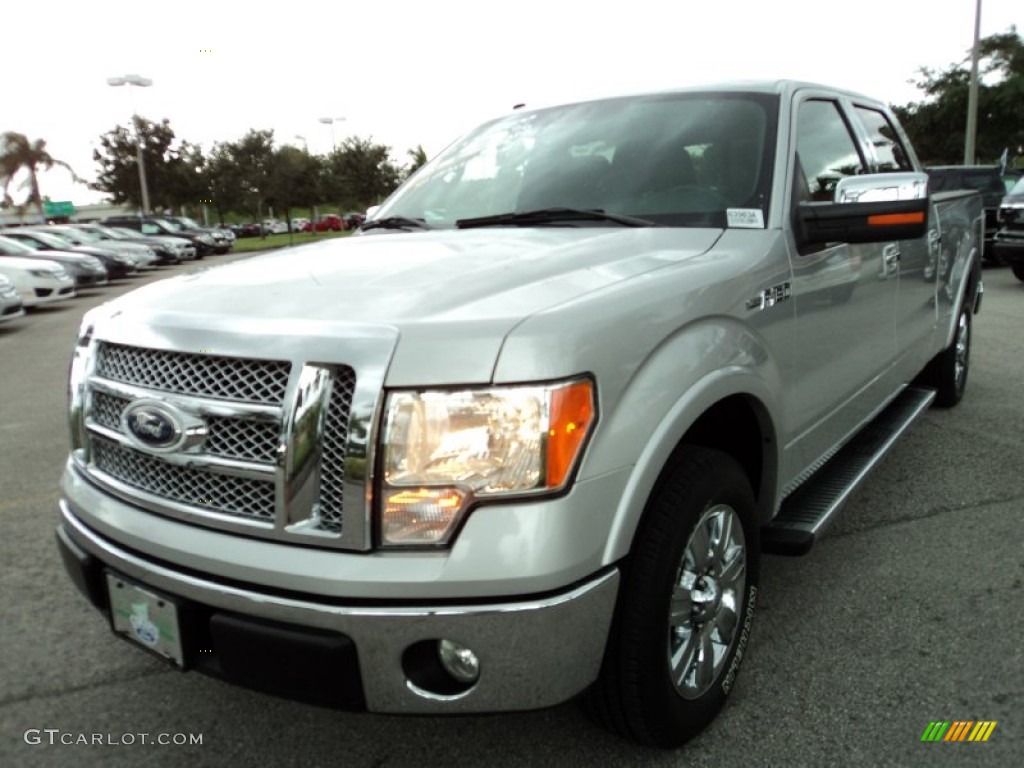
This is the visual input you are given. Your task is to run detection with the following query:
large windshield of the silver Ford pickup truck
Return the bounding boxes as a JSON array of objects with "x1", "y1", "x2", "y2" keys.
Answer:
[{"x1": 374, "y1": 92, "x2": 777, "y2": 227}]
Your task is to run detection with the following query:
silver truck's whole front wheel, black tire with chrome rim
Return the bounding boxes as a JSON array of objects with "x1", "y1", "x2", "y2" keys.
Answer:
[{"x1": 585, "y1": 446, "x2": 760, "y2": 748}]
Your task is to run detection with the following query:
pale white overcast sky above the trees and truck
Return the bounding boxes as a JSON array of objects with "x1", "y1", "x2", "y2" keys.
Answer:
[{"x1": 0, "y1": 0, "x2": 1024, "y2": 205}]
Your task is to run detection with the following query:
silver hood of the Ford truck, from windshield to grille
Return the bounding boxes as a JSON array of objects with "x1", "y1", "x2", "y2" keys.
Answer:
[{"x1": 96, "y1": 226, "x2": 722, "y2": 386}]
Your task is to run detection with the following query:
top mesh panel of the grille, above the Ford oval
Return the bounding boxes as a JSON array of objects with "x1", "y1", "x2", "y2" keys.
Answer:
[{"x1": 96, "y1": 342, "x2": 291, "y2": 404}]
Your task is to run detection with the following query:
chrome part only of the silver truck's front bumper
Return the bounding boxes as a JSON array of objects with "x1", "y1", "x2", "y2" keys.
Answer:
[{"x1": 60, "y1": 500, "x2": 620, "y2": 714}]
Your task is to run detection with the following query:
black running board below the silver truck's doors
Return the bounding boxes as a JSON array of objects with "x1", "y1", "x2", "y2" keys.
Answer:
[{"x1": 761, "y1": 387, "x2": 935, "y2": 555}]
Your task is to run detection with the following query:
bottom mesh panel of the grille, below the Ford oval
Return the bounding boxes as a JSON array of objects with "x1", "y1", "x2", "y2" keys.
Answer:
[{"x1": 92, "y1": 435, "x2": 274, "y2": 522}]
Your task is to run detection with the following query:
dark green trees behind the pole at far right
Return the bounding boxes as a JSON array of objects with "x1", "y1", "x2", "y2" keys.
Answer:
[{"x1": 893, "y1": 27, "x2": 1024, "y2": 165}]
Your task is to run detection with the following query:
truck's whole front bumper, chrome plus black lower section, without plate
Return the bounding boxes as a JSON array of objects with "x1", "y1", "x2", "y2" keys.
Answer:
[{"x1": 57, "y1": 500, "x2": 618, "y2": 714}]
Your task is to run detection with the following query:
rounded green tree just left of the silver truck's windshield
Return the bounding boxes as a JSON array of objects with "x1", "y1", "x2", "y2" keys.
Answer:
[{"x1": 324, "y1": 136, "x2": 402, "y2": 210}]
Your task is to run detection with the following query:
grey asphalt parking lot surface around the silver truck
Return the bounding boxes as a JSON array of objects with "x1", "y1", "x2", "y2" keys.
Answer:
[{"x1": 0, "y1": 257, "x2": 1024, "y2": 768}]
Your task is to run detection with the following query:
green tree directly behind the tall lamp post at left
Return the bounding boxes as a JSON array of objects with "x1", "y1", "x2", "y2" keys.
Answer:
[{"x1": 91, "y1": 116, "x2": 206, "y2": 210}]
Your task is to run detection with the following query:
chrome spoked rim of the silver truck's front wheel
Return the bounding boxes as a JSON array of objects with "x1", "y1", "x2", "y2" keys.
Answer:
[{"x1": 669, "y1": 504, "x2": 746, "y2": 699}]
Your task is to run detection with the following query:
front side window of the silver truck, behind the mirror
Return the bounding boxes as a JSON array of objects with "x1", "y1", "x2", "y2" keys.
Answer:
[{"x1": 796, "y1": 99, "x2": 866, "y2": 202}]
